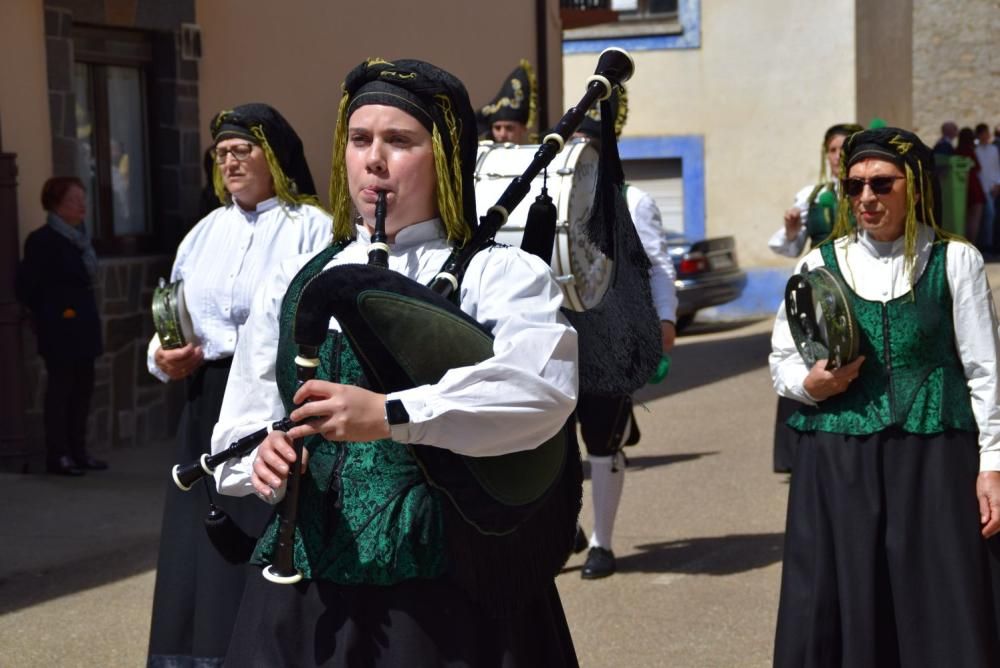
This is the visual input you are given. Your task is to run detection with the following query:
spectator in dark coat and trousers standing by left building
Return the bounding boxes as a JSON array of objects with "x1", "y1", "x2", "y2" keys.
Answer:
[{"x1": 16, "y1": 176, "x2": 108, "y2": 476}]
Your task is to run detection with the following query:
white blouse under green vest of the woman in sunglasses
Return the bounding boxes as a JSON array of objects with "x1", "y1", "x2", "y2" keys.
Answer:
[{"x1": 769, "y1": 225, "x2": 1000, "y2": 471}]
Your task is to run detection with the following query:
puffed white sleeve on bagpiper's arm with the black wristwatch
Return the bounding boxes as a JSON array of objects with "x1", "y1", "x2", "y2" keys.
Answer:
[{"x1": 389, "y1": 247, "x2": 578, "y2": 456}]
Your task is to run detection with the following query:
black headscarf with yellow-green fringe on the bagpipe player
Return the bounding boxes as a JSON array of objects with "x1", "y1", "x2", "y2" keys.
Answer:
[{"x1": 330, "y1": 58, "x2": 478, "y2": 243}]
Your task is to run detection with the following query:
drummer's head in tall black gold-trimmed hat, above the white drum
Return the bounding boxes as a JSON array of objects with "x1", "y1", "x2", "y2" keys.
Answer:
[{"x1": 476, "y1": 59, "x2": 538, "y2": 144}]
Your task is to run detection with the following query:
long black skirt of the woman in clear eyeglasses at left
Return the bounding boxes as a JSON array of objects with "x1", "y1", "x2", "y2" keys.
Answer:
[{"x1": 148, "y1": 359, "x2": 272, "y2": 668}]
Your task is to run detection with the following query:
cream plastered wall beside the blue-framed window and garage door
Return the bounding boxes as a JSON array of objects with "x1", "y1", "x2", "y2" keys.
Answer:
[{"x1": 563, "y1": 0, "x2": 856, "y2": 266}]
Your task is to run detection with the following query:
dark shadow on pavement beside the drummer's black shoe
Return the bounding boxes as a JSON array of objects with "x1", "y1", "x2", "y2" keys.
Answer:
[{"x1": 565, "y1": 533, "x2": 785, "y2": 575}]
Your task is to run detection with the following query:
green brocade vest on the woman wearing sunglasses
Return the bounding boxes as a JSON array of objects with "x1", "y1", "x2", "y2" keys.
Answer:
[{"x1": 788, "y1": 243, "x2": 977, "y2": 436}]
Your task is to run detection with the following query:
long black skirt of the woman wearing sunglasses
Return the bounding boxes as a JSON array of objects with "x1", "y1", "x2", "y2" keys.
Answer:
[{"x1": 774, "y1": 429, "x2": 1000, "y2": 668}]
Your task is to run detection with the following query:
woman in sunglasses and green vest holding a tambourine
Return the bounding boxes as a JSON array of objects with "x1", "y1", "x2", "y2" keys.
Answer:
[{"x1": 770, "y1": 128, "x2": 1000, "y2": 668}]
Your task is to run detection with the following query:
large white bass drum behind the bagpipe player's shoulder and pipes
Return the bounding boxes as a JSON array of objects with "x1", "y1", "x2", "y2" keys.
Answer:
[{"x1": 476, "y1": 140, "x2": 612, "y2": 311}]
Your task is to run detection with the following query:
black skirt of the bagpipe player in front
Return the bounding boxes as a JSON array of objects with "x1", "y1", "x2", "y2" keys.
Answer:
[{"x1": 225, "y1": 572, "x2": 578, "y2": 668}]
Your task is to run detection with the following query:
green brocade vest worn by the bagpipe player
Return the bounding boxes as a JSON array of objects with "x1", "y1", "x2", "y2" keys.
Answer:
[{"x1": 252, "y1": 245, "x2": 447, "y2": 585}]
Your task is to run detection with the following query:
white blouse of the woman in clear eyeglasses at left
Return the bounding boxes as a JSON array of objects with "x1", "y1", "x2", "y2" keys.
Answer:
[{"x1": 146, "y1": 197, "x2": 333, "y2": 382}]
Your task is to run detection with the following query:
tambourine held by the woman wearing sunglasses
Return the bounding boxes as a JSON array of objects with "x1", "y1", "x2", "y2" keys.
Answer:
[{"x1": 785, "y1": 266, "x2": 860, "y2": 370}]
